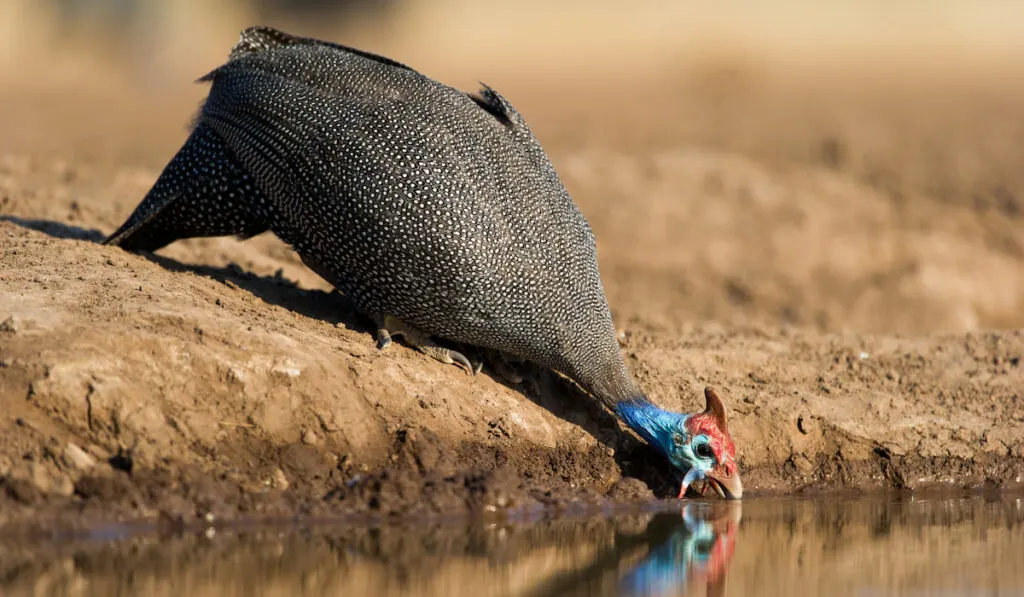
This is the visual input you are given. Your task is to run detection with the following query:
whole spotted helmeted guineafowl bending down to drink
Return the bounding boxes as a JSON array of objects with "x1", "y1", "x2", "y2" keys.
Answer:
[{"x1": 103, "y1": 26, "x2": 742, "y2": 499}]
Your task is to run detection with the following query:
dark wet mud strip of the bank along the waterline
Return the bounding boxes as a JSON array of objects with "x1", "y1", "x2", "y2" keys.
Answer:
[{"x1": 0, "y1": 419, "x2": 1024, "y2": 538}]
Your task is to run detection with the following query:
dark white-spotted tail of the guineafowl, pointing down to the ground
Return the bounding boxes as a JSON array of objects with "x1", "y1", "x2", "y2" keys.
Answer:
[{"x1": 103, "y1": 123, "x2": 270, "y2": 251}]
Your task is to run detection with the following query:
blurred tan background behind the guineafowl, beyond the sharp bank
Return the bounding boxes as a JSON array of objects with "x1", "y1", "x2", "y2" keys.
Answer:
[{"x1": 0, "y1": 0, "x2": 1024, "y2": 334}]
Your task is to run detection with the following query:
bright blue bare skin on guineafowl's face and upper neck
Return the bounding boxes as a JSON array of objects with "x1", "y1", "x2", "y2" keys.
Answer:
[{"x1": 615, "y1": 401, "x2": 716, "y2": 488}]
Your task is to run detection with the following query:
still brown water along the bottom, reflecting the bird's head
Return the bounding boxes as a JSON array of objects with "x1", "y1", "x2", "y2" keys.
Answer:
[{"x1": 0, "y1": 496, "x2": 1024, "y2": 597}]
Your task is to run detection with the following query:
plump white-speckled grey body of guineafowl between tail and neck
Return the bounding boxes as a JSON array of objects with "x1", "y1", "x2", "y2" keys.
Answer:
[{"x1": 191, "y1": 33, "x2": 613, "y2": 382}]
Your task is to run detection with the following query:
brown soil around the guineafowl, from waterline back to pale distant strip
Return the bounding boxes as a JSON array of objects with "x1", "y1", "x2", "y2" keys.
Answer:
[{"x1": 0, "y1": 4, "x2": 1024, "y2": 536}]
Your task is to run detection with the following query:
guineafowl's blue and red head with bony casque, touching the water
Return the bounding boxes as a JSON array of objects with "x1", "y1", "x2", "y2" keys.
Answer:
[{"x1": 616, "y1": 387, "x2": 743, "y2": 500}]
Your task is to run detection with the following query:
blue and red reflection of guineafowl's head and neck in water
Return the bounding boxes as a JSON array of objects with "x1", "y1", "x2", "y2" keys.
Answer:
[{"x1": 535, "y1": 502, "x2": 742, "y2": 597}]
